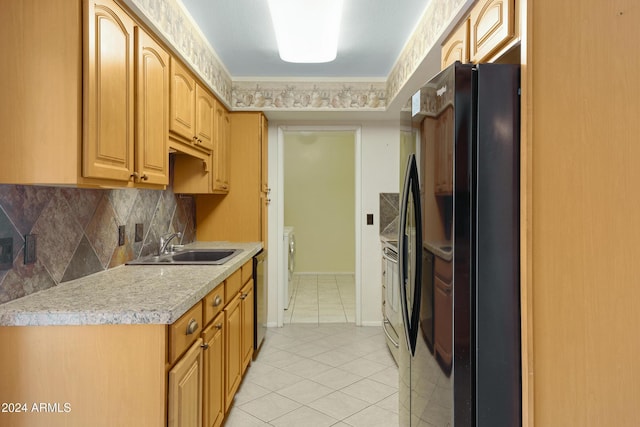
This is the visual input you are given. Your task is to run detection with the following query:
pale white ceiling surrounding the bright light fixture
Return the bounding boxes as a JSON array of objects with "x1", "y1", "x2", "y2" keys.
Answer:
[{"x1": 182, "y1": 0, "x2": 430, "y2": 79}]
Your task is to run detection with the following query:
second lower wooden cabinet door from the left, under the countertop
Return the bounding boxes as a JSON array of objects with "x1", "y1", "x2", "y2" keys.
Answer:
[{"x1": 202, "y1": 313, "x2": 225, "y2": 427}]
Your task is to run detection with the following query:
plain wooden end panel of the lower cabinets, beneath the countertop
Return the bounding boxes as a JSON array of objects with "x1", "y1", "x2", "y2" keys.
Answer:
[{"x1": 0, "y1": 325, "x2": 167, "y2": 427}]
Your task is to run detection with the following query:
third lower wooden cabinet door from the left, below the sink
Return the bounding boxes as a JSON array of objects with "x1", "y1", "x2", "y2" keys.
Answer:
[{"x1": 224, "y1": 294, "x2": 242, "y2": 410}]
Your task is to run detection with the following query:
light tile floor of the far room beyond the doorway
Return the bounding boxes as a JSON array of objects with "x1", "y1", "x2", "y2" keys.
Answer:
[{"x1": 284, "y1": 274, "x2": 356, "y2": 323}]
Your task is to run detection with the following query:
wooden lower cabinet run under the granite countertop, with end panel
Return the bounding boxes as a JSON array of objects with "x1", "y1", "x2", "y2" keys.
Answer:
[{"x1": 0, "y1": 261, "x2": 254, "y2": 427}]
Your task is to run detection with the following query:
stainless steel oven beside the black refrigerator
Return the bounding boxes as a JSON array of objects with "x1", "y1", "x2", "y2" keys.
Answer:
[{"x1": 382, "y1": 240, "x2": 402, "y2": 364}]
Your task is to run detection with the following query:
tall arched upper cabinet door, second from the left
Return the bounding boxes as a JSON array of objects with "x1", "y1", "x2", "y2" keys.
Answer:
[{"x1": 135, "y1": 27, "x2": 169, "y2": 185}]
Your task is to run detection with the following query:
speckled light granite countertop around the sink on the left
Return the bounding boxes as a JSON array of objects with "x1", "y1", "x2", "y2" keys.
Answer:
[{"x1": 0, "y1": 242, "x2": 262, "y2": 326}]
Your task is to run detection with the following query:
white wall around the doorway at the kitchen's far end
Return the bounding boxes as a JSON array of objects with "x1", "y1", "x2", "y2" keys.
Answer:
[{"x1": 268, "y1": 121, "x2": 400, "y2": 326}]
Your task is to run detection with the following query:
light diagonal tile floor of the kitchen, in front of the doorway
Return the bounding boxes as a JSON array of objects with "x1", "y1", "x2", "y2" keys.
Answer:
[{"x1": 225, "y1": 321, "x2": 398, "y2": 427}]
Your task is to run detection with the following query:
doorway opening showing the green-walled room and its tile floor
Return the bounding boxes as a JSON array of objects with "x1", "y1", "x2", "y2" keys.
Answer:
[{"x1": 278, "y1": 127, "x2": 360, "y2": 326}]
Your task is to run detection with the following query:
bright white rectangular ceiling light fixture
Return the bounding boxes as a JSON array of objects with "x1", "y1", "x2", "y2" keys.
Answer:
[{"x1": 268, "y1": 0, "x2": 343, "y2": 63}]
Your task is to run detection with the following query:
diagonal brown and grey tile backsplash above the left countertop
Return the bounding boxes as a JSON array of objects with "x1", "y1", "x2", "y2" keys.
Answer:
[{"x1": 0, "y1": 159, "x2": 195, "y2": 303}]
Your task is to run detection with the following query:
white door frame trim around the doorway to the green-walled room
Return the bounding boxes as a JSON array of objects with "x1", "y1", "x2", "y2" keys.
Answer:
[{"x1": 271, "y1": 125, "x2": 362, "y2": 327}]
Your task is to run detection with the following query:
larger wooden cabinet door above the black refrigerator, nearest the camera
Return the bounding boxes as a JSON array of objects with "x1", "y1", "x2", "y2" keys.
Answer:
[{"x1": 469, "y1": 0, "x2": 515, "y2": 63}]
